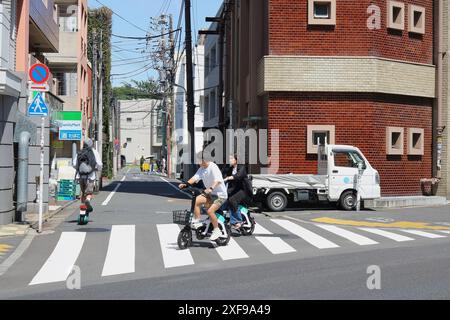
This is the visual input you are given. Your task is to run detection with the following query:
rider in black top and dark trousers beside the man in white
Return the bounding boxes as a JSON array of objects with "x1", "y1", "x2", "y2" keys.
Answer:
[{"x1": 222, "y1": 154, "x2": 252, "y2": 229}]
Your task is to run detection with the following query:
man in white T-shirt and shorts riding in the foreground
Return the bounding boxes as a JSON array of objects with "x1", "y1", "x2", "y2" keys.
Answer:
[{"x1": 179, "y1": 152, "x2": 228, "y2": 241}]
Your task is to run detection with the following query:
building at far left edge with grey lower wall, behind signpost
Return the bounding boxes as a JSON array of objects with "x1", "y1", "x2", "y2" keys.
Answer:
[{"x1": 0, "y1": 0, "x2": 62, "y2": 224}]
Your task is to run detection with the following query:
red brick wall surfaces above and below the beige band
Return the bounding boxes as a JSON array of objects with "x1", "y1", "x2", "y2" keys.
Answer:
[{"x1": 266, "y1": 0, "x2": 433, "y2": 196}]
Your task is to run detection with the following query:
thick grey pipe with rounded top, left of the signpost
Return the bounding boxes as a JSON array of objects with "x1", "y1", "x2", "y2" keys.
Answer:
[{"x1": 17, "y1": 131, "x2": 31, "y2": 222}]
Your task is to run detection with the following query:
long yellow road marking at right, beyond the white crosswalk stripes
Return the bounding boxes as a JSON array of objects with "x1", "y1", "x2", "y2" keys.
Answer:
[{"x1": 311, "y1": 217, "x2": 450, "y2": 230}]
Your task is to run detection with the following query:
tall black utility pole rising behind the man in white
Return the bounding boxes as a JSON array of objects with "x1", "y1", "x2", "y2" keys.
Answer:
[{"x1": 184, "y1": 0, "x2": 195, "y2": 176}]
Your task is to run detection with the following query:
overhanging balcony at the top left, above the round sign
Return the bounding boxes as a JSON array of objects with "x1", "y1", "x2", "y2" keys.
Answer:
[{"x1": 30, "y1": 0, "x2": 59, "y2": 52}]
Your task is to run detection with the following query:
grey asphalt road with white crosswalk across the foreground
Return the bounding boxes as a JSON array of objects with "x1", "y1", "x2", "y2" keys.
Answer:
[{"x1": 0, "y1": 168, "x2": 450, "y2": 300}]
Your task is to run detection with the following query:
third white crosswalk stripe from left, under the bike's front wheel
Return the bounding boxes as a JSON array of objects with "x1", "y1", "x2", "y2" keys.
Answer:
[{"x1": 156, "y1": 224, "x2": 194, "y2": 268}]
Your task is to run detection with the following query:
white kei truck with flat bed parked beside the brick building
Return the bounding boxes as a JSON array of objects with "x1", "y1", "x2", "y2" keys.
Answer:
[{"x1": 251, "y1": 145, "x2": 381, "y2": 212}]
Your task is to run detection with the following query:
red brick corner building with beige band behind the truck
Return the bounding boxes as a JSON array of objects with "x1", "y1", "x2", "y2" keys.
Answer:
[{"x1": 222, "y1": 0, "x2": 436, "y2": 195}]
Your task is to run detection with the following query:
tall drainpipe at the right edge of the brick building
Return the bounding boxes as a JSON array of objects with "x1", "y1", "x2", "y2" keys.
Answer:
[{"x1": 433, "y1": 0, "x2": 445, "y2": 179}]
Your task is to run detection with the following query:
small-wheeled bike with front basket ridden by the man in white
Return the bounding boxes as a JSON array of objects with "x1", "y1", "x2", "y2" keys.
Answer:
[{"x1": 173, "y1": 187, "x2": 231, "y2": 250}]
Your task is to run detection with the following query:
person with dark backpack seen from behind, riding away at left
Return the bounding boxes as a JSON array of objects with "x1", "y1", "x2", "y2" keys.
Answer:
[{"x1": 72, "y1": 138, "x2": 103, "y2": 215}]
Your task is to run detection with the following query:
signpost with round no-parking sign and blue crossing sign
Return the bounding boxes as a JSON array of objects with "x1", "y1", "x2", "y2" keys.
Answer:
[{"x1": 28, "y1": 63, "x2": 50, "y2": 233}]
